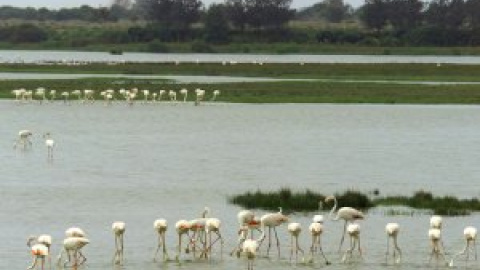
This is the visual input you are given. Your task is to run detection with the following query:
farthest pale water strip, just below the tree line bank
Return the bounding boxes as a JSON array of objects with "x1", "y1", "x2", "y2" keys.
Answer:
[{"x1": 0, "y1": 50, "x2": 480, "y2": 65}]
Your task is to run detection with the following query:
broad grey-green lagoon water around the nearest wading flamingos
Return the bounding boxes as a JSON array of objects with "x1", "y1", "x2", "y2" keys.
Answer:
[{"x1": 0, "y1": 101, "x2": 480, "y2": 270}]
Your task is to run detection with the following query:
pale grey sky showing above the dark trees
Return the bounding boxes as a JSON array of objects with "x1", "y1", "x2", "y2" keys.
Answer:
[{"x1": 0, "y1": 0, "x2": 364, "y2": 9}]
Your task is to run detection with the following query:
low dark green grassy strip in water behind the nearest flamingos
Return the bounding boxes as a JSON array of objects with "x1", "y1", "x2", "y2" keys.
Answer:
[{"x1": 228, "y1": 188, "x2": 480, "y2": 216}]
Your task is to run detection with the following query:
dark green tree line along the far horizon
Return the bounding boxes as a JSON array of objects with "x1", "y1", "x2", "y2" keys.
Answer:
[{"x1": 0, "y1": 0, "x2": 480, "y2": 46}]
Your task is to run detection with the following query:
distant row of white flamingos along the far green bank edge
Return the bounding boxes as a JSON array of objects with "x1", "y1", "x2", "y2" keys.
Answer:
[{"x1": 11, "y1": 87, "x2": 220, "y2": 106}]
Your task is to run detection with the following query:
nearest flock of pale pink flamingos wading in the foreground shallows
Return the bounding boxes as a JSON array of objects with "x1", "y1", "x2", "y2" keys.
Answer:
[{"x1": 23, "y1": 199, "x2": 477, "y2": 270}]
